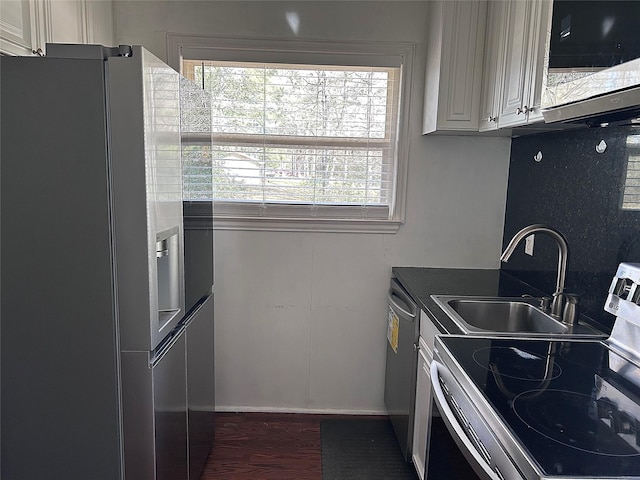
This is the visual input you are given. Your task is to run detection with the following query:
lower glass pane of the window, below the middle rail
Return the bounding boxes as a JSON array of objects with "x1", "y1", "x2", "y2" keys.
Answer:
[{"x1": 208, "y1": 145, "x2": 391, "y2": 205}]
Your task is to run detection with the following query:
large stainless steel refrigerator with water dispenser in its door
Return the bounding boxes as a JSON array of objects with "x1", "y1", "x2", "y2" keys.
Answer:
[{"x1": 0, "y1": 44, "x2": 214, "y2": 480}]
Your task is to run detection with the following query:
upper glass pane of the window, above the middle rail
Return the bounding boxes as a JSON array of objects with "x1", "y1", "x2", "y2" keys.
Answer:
[{"x1": 195, "y1": 62, "x2": 397, "y2": 138}]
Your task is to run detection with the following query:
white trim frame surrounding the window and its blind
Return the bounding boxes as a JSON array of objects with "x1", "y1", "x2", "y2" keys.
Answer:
[{"x1": 167, "y1": 33, "x2": 415, "y2": 233}]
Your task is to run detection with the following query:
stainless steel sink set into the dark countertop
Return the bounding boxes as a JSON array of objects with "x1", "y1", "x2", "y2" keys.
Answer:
[{"x1": 431, "y1": 295, "x2": 604, "y2": 337}]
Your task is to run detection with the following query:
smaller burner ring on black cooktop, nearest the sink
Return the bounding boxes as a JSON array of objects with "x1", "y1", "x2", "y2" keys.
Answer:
[{"x1": 473, "y1": 347, "x2": 562, "y2": 381}]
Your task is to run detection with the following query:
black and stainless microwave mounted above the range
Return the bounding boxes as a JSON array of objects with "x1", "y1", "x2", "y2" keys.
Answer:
[{"x1": 542, "y1": 0, "x2": 640, "y2": 124}]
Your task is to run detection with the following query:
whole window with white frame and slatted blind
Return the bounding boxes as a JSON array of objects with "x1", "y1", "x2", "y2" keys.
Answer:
[{"x1": 170, "y1": 34, "x2": 411, "y2": 231}]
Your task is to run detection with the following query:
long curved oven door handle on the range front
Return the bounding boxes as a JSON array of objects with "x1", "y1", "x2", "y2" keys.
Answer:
[{"x1": 431, "y1": 360, "x2": 501, "y2": 480}]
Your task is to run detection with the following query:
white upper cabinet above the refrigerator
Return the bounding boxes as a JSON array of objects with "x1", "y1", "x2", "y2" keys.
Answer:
[{"x1": 0, "y1": 0, "x2": 114, "y2": 55}]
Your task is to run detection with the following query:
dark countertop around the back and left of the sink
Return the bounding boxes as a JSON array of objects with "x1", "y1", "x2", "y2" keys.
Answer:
[{"x1": 392, "y1": 267, "x2": 604, "y2": 334}]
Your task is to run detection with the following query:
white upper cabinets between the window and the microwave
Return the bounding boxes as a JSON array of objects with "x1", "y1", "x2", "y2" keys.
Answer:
[{"x1": 423, "y1": 0, "x2": 552, "y2": 134}]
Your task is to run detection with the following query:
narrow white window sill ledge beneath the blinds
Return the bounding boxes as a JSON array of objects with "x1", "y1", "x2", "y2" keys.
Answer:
[{"x1": 184, "y1": 215, "x2": 402, "y2": 234}]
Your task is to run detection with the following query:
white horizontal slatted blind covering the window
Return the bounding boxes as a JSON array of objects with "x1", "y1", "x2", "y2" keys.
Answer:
[{"x1": 183, "y1": 60, "x2": 401, "y2": 219}]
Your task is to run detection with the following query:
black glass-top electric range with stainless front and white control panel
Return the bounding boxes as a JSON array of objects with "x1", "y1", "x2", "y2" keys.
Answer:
[{"x1": 431, "y1": 264, "x2": 640, "y2": 480}]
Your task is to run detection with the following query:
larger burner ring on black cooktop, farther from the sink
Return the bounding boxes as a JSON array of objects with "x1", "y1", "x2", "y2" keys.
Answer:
[{"x1": 513, "y1": 389, "x2": 640, "y2": 457}]
